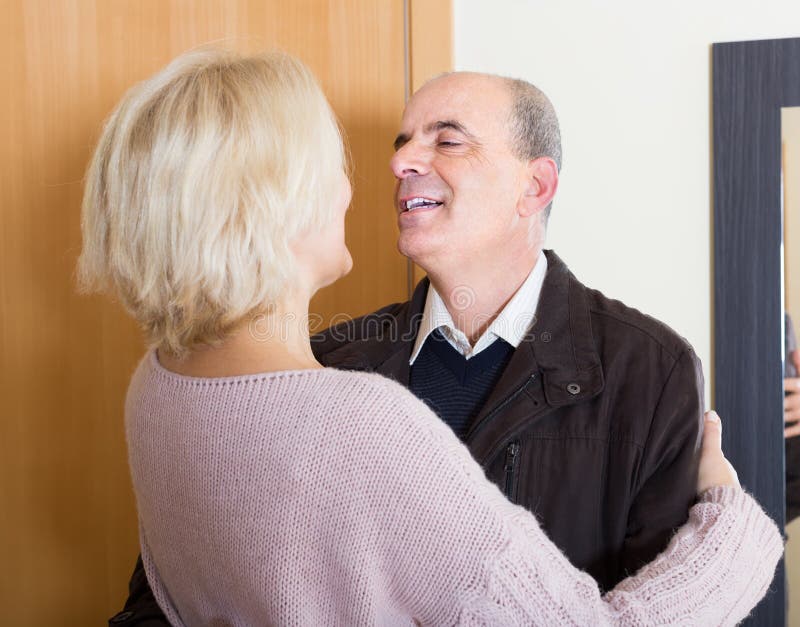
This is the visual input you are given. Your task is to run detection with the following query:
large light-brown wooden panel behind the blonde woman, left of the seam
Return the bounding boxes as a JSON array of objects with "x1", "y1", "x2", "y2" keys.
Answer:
[{"x1": 0, "y1": 0, "x2": 407, "y2": 626}]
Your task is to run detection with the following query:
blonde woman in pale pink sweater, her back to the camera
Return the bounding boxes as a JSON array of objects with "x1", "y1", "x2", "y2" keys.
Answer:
[{"x1": 79, "y1": 51, "x2": 782, "y2": 625}]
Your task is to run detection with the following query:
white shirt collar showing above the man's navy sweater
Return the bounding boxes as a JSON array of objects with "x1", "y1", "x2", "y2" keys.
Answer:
[{"x1": 408, "y1": 252, "x2": 547, "y2": 365}]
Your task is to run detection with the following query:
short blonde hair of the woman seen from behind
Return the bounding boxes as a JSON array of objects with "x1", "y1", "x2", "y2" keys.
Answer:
[{"x1": 78, "y1": 49, "x2": 346, "y2": 356}]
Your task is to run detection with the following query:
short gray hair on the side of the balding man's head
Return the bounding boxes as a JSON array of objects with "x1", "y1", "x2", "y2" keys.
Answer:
[{"x1": 504, "y1": 78, "x2": 561, "y2": 224}]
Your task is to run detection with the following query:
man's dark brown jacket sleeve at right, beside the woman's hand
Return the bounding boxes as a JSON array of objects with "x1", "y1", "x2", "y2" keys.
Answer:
[{"x1": 620, "y1": 347, "x2": 704, "y2": 578}]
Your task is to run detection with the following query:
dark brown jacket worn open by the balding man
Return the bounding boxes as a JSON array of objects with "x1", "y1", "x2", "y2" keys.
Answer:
[{"x1": 112, "y1": 251, "x2": 704, "y2": 625}]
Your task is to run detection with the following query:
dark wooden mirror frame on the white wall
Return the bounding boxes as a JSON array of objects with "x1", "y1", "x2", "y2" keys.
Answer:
[{"x1": 712, "y1": 38, "x2": 800, "y2": 627}]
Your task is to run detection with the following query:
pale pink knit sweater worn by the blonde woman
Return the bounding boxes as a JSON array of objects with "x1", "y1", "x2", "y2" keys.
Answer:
[{"x1": 126, "y1": 351, "x2": 783, "y2": 626}]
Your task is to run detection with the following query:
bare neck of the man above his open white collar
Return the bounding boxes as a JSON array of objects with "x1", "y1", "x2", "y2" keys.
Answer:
[{"x1": 428, "y1": 249, "x2": 541, "y2": 345}]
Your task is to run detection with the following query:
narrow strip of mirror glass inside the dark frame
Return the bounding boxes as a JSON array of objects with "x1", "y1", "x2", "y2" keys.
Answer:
[{"x1": 781, "y1": 107, "x2": 800, "y2": 627}]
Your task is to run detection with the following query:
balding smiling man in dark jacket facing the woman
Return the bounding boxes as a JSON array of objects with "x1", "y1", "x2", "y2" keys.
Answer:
[{"x1": 112, "y1": 73, "x2": 703, "y2": 624}]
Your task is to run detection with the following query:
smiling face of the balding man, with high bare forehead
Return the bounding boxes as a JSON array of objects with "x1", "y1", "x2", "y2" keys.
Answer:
[{"x1": 391, "y1": 74, "x2": 527, "y2": 272}]
